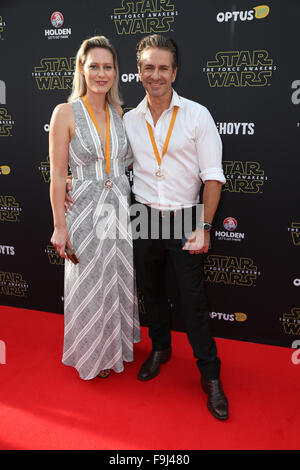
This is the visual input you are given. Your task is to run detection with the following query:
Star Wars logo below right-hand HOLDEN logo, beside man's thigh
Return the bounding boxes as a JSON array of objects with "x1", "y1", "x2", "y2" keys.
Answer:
[{"x1": 204, "y1": 255, "x2": 260, "y2": 287}]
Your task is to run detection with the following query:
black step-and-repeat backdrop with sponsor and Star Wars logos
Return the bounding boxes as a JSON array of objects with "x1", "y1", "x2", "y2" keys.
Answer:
[{"x1": 0, "y1": 0, "x2": 300, "y2": 347}]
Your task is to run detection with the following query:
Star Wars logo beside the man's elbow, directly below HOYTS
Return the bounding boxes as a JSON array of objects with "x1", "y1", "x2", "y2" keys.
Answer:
[{"x1": 223, "y1": 160, "x2": 268, "y2": 194}]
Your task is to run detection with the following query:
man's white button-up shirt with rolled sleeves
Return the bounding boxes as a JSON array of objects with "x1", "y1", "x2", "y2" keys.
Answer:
[{"x1": 124, "y1": 90, "x2": 226, "y2": 208}]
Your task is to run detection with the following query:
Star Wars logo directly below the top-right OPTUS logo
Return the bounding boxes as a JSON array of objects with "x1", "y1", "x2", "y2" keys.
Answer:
[{"x1": 203, "y1": 49, "x2": 276, "y2": 88}]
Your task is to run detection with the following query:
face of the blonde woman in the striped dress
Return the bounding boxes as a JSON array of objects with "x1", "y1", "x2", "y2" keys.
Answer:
[{"x1": 81, "y1": 47, "x2": 116, "y2": 94}]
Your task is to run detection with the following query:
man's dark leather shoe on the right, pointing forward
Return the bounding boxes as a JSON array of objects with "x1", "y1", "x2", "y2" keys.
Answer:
[{"x1": 201, "y1": 377, "x2": 228, "y2": 420}]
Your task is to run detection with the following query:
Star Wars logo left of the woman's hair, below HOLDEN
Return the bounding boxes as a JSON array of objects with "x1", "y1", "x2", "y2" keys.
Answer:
[{"x1": 32, "y1": 57, "x2": 75, "y2": 90}]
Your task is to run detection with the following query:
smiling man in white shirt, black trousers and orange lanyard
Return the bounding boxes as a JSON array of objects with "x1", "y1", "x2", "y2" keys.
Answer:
[{"x1": 124, "y1": 34, "x2": 228, "y2": 420}]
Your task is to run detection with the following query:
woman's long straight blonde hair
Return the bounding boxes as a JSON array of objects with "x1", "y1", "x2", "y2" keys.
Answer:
[{"x1": 68, "y1": 36, "x2": 123, "y2": 106}]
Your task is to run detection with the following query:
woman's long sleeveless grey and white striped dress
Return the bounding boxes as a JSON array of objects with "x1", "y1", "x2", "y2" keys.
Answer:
[{"x1": 62, "y1": 98, "x2": 140, "y2": 380}]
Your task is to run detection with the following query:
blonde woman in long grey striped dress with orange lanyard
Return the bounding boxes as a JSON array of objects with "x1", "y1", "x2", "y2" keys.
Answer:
[{"x1": 49, "y1": 36, "x2": 140, "y2": 380}]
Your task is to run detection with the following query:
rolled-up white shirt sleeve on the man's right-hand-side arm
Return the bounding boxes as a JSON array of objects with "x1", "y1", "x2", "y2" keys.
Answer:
[{"x1": 195, "y1": 107, "x2": 226, "y2": 184}]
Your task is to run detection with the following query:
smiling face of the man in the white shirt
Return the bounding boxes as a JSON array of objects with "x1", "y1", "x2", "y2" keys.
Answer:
[{"x1": 138, "y1": 47, "x2": 177, "y2": 98}]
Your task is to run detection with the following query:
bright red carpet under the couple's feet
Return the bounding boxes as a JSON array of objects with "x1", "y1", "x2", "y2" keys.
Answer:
[{"x1": 0, "y1": 306, "x2": 300, "y2": 450}]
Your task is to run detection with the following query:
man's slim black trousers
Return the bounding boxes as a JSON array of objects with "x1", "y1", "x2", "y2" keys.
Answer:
[{"x1": 133, "y1": 204, "x2": 220, "y2": 379}]
